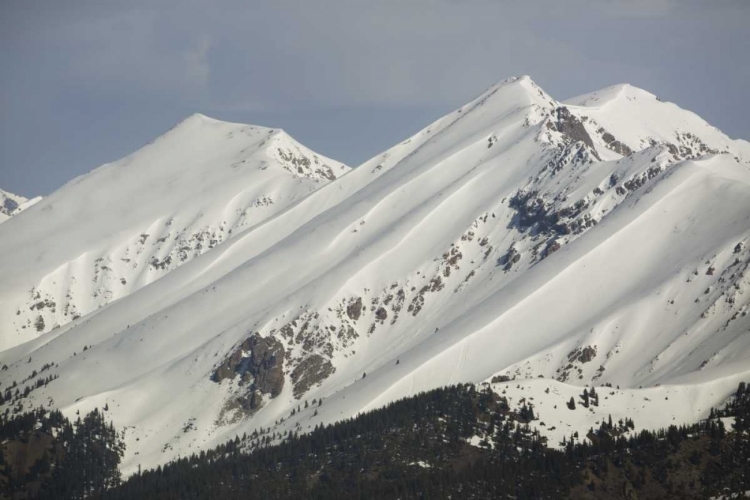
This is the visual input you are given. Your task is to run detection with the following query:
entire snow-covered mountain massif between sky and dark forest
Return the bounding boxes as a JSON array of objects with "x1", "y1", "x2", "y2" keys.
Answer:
[{"x1": 0, "y1": 77, "x2": 750, "y2": 472}]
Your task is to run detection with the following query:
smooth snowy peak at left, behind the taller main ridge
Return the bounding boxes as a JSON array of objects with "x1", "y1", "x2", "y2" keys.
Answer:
[{"x1": 0, "y1": 115, "x2": 348, "y2": 348}]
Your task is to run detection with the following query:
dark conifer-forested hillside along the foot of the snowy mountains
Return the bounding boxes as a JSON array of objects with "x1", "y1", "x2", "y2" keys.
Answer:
[{"x1": 0, "y1": 383, "x2": 750, "y2": 500}]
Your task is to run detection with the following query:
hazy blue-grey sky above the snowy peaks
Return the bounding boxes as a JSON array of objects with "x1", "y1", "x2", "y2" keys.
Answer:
[{"x1": 0, "y1": 0, "x2": 750, "y2": 196}]
